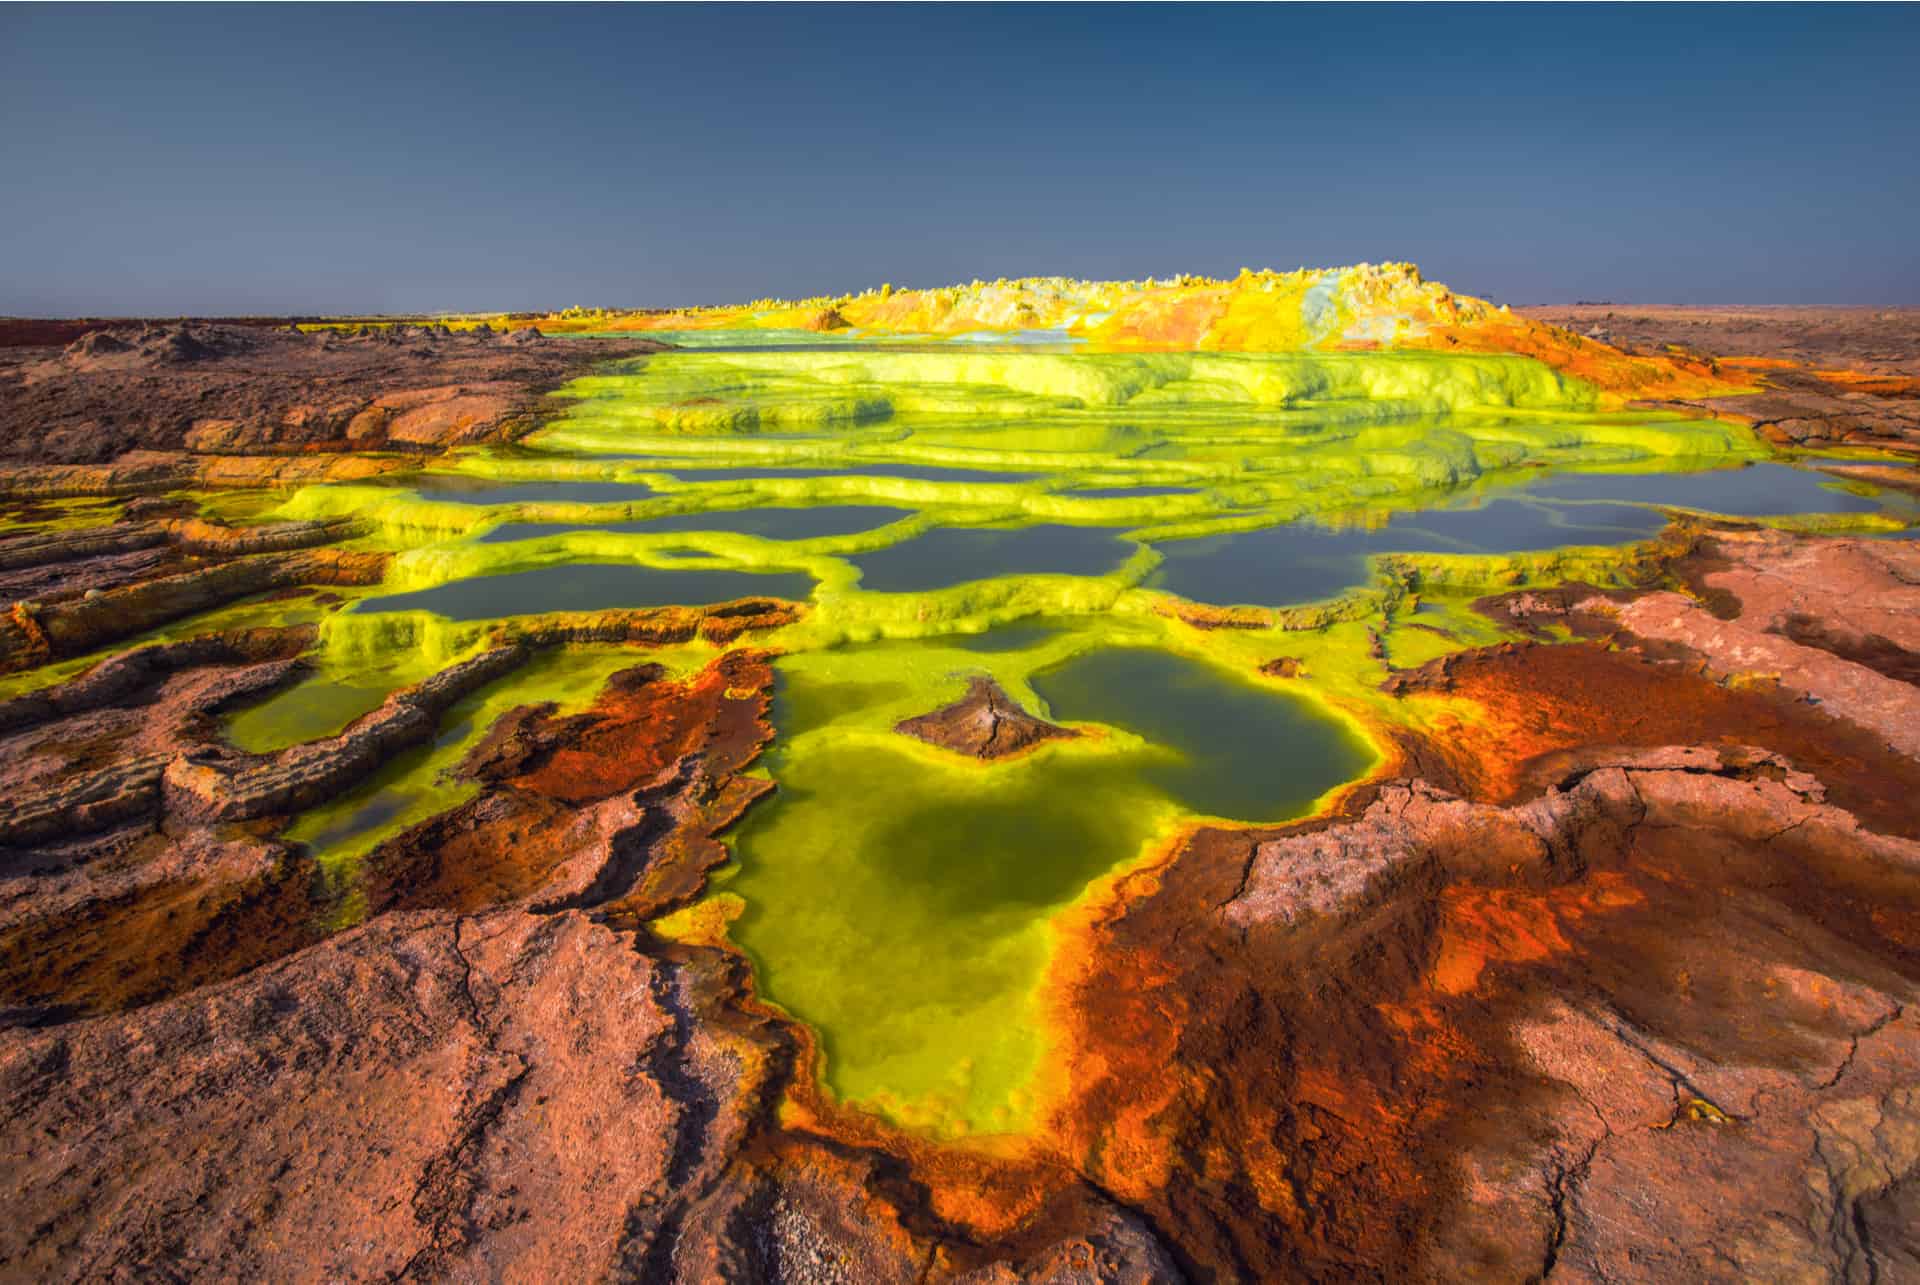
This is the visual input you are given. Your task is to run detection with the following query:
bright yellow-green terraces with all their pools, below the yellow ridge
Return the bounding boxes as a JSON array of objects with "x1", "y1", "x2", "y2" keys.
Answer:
[{"x1": 172, "y1": 336, "x2": 1901, "y2": 1137}]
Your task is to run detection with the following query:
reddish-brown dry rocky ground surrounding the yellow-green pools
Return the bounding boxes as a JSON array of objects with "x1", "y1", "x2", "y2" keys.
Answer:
[{"x1": 0, "y1": 307, "x2": 1920, "y2": 1281}]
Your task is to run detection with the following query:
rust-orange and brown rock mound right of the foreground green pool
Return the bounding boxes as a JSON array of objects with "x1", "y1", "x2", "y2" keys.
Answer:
[{"x1": 1054, "y1": 751, "x2": 1920, "y2": 1279}]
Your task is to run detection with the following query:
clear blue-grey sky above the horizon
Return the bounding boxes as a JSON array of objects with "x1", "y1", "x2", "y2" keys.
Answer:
[{"x1": 0, "y1": 4, "x2": 1920, "y2": 315}]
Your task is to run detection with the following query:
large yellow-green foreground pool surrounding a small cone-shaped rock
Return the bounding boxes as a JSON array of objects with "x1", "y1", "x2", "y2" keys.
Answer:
[{"x1": 726, "y1": 638, "x2": 1373, "y2": 1135}]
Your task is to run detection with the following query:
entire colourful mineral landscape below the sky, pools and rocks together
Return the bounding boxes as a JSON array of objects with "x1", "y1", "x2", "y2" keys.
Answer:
[{"x1": 0, "y1": 269, "x2": 1920, "y2": 1279}]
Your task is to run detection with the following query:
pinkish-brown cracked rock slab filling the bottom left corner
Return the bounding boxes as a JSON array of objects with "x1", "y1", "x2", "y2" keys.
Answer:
[{"x1": 0, "y1": 912, "x2": 733, "y2": 1279}]
